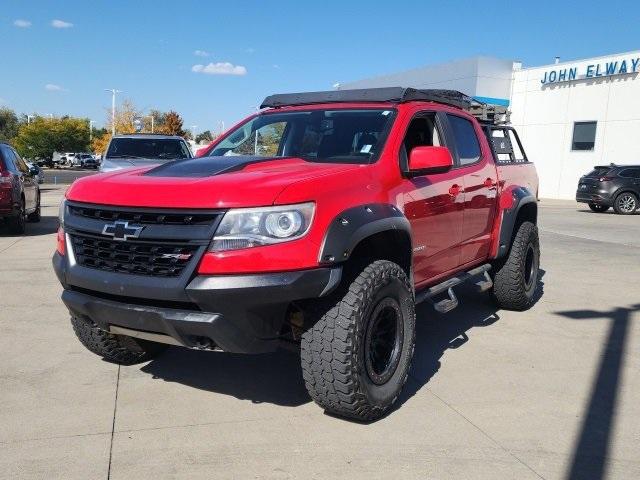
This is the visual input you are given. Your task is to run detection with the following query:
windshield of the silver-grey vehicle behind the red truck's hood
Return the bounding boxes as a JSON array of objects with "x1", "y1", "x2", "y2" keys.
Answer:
[{"x1": 106, "y1": 138, "x2": 191, "y2": 160}]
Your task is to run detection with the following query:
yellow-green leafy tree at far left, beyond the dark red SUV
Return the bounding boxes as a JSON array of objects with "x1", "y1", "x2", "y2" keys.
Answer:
[{"x1": 13, "y1": 117, "x2": 89, "y2": 158}]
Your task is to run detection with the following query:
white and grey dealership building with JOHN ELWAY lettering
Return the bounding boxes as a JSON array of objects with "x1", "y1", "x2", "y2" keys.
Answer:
[{"x1": 340, "y1": 51, "x2": 640, "y2": 199}]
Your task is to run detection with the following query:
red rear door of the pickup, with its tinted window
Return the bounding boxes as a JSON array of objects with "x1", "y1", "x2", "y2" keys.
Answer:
[{"x1": 447, "y1": 113, "x2": 498, "y2": 265}]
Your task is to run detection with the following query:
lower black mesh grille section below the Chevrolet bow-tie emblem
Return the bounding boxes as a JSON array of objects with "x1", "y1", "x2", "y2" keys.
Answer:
[{"x1": 70, "y1": 233, "x2": 199, "y2": 277}]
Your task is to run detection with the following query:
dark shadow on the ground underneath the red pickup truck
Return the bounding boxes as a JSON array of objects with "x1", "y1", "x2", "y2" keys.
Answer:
[{"x1": 141, "y1": 270, "x2": 544, "y2": 408}]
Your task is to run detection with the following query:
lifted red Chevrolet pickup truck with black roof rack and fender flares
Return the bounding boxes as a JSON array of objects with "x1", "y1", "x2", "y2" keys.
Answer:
[{"x1": 53, "y1": 88, "x2": 540, "y2": 420}]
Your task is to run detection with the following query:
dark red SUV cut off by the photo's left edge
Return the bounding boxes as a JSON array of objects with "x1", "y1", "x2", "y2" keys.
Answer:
[{"x1": 0, "y1": 142, "x2": 40, "y2": 234}]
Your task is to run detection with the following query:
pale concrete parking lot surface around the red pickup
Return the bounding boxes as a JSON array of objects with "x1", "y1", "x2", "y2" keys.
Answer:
[{"x1": 0, "y1": 185, "x2": 640, "y2": 480}]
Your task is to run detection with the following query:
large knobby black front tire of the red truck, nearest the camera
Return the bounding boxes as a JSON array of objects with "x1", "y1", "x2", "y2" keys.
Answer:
[{"x1": 301, "y1": 260, "x2": 416, "y2": 421}]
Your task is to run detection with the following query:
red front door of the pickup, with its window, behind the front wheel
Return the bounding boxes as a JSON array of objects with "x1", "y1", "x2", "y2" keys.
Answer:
[{"x1": 400, "y1": 112, "x2": 464, "y2": 286}]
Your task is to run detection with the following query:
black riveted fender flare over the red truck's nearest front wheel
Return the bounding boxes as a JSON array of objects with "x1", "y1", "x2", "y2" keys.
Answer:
[{"x1": 318, "y1": 203, "x2": 411, "y2": 264}]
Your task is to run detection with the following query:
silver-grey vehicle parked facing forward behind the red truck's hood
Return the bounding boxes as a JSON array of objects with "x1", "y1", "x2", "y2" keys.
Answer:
[{"x1": 100, "y1": 134, "x2": 193, "y2": 172}]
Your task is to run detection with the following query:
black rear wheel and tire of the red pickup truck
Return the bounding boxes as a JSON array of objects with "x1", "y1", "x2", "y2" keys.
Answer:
[{"x1": 493, "y1": 222, "x2": 540, "y2": 311}]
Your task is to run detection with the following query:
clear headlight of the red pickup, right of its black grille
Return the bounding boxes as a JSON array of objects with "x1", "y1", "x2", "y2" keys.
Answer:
[{"x1": 209, "y1": 203, "x2": 315, "y2": 252}]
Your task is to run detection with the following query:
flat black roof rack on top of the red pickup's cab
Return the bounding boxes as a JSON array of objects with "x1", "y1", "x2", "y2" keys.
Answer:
[{"x1": 260, "y1": 87, "x2": 509, "y2": 123}]
